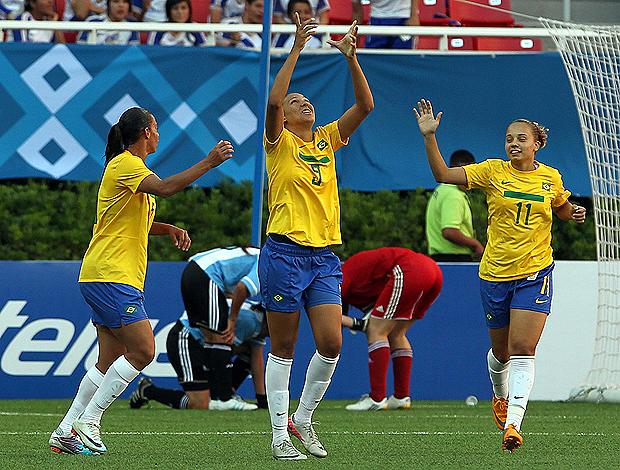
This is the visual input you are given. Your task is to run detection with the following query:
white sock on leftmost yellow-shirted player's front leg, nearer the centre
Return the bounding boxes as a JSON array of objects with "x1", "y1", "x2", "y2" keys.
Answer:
[{"x1": 80, "y1": 356, "x2": 140, "y2": 423}]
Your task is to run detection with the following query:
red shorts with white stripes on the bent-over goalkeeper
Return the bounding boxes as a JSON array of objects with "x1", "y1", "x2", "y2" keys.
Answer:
[{"x1": 371, "y1": 258, "x2": 443, "y2": 320}]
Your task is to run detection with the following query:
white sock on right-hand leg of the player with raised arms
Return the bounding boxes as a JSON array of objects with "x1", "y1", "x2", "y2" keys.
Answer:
[{"x1": 295, "y1": 351, "x2": 340, "y2": 423}]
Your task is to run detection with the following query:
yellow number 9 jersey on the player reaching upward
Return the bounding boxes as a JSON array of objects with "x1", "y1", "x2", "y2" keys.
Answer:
[{"x1": 264, "y1": 121, "x2": 348, "y2": 247}]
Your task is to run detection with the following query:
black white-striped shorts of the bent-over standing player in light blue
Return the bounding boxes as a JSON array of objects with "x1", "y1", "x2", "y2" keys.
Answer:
[{"x1": 181, "y1": 261, "x2": 228, "y2": 333}]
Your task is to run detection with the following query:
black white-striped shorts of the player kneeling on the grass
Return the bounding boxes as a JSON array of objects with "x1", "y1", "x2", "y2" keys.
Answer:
[{"x1": 166, "y1": 321, "x2": 209, "y2": 392}]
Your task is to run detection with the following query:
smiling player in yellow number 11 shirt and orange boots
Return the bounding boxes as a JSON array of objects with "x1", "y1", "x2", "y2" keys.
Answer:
[{"x1": 414, "y1": 100, "x2": 586, "y2": 452}]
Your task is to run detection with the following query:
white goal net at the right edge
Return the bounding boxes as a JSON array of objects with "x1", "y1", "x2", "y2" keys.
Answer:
[{"x1": 540, "y1": 18, "x2": 620, "y2": 402}]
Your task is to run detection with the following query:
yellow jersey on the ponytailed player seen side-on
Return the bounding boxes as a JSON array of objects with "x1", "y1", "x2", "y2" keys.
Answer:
[{"x1": 79, "y1": 151, "x2": 155, "y2": 291}]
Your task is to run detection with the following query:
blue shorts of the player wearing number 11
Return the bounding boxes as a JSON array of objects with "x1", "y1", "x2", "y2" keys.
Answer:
[{"x1": 480, "y1": 263, "x2": 555, "y2": 328}]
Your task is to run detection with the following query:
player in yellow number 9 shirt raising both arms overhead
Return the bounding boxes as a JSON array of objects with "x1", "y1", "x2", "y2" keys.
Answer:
[{"x1": 259, "y1": 15, "x2": 374, "y2": 460}]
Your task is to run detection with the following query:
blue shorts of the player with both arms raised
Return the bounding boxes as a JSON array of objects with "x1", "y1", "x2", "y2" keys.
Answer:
[{"x1": 258, "y1": 237, "x2": 342, "y2": 313}]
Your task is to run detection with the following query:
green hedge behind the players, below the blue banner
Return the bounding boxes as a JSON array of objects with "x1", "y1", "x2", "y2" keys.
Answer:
[{"x1": 0, "y1": 180, "x2": 596, "y2": 261}]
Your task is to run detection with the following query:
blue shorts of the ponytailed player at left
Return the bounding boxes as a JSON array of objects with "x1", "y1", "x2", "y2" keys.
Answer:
[{"x1": 80, "y1": 282, "x2": 148, "y2": 328}]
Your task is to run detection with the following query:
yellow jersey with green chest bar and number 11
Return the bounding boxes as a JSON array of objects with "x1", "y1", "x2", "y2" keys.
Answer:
[{"x1": 463, "y1": 160, "x2": 570, "y2": 281}]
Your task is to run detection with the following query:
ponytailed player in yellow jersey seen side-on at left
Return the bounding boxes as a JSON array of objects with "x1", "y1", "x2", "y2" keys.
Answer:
[{"x1": 49, "y1": 108, "x2": 233, "y2": 455}]
